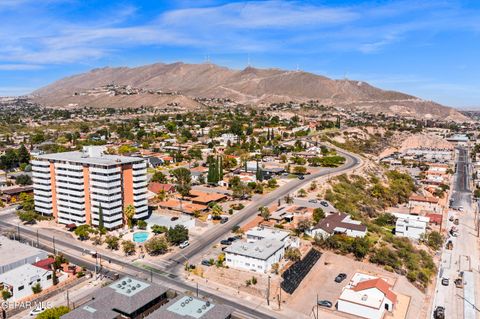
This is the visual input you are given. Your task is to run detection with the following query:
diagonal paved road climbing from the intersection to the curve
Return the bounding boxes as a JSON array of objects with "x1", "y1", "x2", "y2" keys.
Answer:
[{"x1": 165, "y1": 150, "x2": 360, "y2": 267}]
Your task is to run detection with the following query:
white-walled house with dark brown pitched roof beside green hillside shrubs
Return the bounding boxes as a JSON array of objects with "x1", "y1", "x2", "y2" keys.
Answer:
[{"x1": 306, "y1": 212, "x2": 367, "y2": 238}]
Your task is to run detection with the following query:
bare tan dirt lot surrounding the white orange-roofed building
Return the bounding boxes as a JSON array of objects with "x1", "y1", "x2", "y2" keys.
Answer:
[{"x1": 282, "y1": 252, "x2": 424, "y2": 319}]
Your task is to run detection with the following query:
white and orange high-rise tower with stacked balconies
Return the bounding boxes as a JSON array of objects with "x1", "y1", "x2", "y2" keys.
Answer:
[{"x1": 32, "y1": 146, "x2": 148, "y2": 229}]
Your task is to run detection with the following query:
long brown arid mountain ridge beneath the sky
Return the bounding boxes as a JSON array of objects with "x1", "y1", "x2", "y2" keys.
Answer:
[{"x1": 32, "y1": 63, "x2": 466, "y2": 121}]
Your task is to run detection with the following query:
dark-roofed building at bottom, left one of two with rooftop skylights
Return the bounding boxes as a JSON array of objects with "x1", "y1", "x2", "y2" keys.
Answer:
[{"x1": 61, "y1": 277, "x2": 168, "y2": 319}]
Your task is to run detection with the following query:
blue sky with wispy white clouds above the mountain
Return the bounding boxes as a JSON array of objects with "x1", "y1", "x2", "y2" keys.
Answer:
[{"x1": 0, "y1": 0, "x2": 480, "y2": 107}]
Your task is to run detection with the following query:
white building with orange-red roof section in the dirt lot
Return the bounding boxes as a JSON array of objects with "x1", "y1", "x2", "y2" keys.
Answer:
[{"x1": 337, "y1": 273, "x2": 397, "y2": 319}]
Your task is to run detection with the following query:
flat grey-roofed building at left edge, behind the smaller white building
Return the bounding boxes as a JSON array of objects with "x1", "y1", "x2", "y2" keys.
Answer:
[{"x1": 0, "y1": 236, "x2": 48, "y2": 274}]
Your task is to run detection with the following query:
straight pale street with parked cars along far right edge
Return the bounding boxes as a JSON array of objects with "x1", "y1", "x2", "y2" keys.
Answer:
[{"x1": 431, "y1": 148, "x2": 480, "y2": 319}]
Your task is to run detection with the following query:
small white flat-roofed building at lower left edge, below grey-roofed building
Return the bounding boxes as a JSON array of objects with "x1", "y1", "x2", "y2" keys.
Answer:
[{"x1": 0, "y1": 264, "x2": 53, "y2": 301}]
